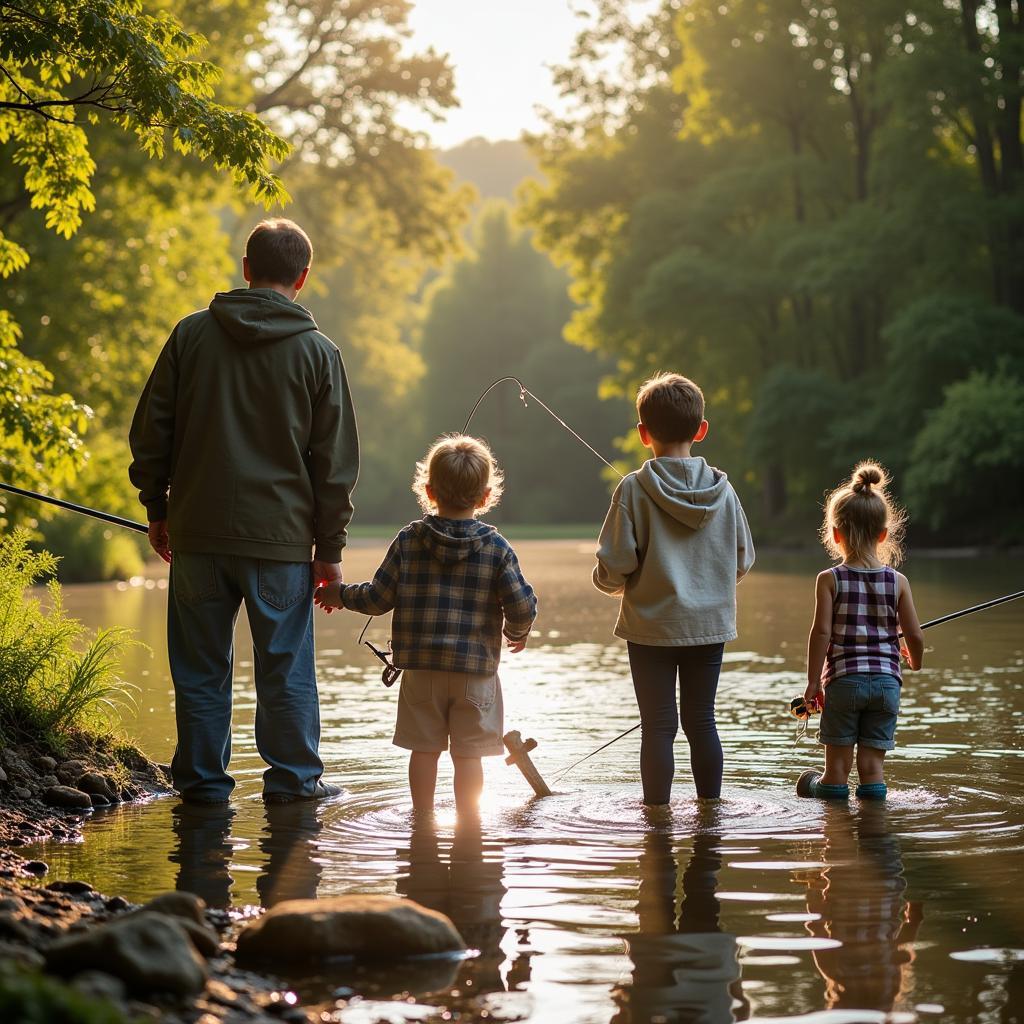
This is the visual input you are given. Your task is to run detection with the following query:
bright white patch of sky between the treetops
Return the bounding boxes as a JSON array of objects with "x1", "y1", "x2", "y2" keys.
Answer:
[{"x1": 410, "y1": 0, "x2": 586, "y2": 148}]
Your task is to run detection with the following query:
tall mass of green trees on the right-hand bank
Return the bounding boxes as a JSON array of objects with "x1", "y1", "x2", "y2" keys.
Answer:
[{"x1": 526, "y1": 0, "x2": 1024, "y2": 540}]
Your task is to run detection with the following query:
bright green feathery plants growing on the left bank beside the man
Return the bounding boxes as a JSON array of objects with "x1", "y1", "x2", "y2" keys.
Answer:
[{"x1": 0, "y1": 529, "x2": 136, "y2": 751}]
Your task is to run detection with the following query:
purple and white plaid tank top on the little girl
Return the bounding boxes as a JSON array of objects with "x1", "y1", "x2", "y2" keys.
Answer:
[{"x1": 821, "y1": 565, "x2": 903, "y2": 683}]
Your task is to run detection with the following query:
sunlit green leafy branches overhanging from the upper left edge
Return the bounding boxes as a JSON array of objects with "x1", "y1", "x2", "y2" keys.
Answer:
[{"x1": 0, "y1": 0, "x2": 288, "y2": 512}]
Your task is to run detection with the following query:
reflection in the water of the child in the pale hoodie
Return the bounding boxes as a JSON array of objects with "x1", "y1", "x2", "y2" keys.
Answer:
[{"x1": 612, "y1": 829, "x2": 750, "y2": 1024}]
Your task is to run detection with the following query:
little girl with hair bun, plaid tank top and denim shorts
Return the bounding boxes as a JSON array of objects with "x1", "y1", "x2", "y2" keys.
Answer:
[{"x1": 797, "y1": 462, "x2": 925, "y2": 800}]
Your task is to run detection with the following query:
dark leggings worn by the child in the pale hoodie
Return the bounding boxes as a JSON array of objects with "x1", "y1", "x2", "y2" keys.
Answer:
[{"x1": 629, "y1": 643, "x2": 725, "y2": 804}]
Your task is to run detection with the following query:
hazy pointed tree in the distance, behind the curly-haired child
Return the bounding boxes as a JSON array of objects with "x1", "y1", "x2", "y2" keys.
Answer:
[{"x1": 407, "y1": 202, "x2": 632, "y2": 523}]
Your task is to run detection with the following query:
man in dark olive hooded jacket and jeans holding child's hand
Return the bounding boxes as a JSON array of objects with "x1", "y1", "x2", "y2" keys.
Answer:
[{"x1": 129, "y1": 219, "x2": 359, "y2": 804}]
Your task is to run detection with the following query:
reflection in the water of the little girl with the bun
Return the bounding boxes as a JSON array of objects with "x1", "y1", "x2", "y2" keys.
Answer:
[{"x1": 807, "y1": 803, "x2": 923, "y2": 1012}]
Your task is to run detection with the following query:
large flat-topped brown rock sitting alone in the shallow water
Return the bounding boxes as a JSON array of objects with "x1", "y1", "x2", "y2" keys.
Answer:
[{"x1": 236, "y1": 896, "x2": 466, "y2": 964}]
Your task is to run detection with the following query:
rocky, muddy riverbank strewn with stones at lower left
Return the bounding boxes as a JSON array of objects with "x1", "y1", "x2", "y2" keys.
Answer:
[{"x1": 0, "y1": 739, "x2": 317, "y2": 1024}]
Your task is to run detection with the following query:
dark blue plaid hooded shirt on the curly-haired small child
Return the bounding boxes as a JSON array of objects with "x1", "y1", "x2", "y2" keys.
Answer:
[{"x1": 341, "y1": 515, "x2": 537, "y2": 673}]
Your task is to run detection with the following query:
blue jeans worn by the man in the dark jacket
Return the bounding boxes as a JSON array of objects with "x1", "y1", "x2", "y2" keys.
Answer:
[{"x1": 167, "y1": 552, "x2": 324, "y2": 801}]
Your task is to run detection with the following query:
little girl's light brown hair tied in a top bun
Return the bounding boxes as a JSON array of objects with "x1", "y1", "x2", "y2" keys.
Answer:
[{"x1": 821, "y1": 461, "x2": 906, "y2": 565}]
